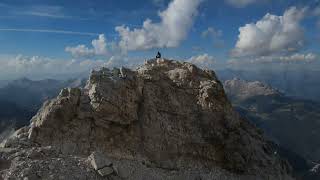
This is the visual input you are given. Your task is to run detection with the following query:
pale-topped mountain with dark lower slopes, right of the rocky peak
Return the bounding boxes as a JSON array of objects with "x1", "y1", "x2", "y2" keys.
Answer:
[{"x1": 224, "y1": 79, "x2": 320, "y2": 179}]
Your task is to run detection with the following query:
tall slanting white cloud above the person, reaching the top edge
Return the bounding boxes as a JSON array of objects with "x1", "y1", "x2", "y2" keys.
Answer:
[{"x1": 115, "y1": 0, "x2": 202, "y2": 50}]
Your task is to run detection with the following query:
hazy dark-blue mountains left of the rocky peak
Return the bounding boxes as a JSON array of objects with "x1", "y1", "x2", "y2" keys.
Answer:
[{"x1": 0, "y1": 78, "x2": 85, "y2": 133}]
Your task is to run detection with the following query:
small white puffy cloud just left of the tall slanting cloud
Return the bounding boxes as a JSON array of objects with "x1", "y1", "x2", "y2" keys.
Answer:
[{"x1": 65, "y1": 34, "x2": 108, "y2": 57}]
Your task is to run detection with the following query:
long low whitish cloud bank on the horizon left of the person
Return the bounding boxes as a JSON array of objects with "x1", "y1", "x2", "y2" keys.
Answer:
[{"x1": 0, "y1": 55, "x2": 151, "y2": 81}]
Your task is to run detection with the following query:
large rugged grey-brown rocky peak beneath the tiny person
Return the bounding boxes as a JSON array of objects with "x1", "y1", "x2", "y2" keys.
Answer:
[{"x1": 0, "y1": 58, "x2": 292, "y2": 180}]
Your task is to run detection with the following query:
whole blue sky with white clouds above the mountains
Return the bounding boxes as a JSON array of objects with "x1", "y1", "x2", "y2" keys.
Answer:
[{"x1": 0, "y1": 0, "x2": 320, "y2": 80}]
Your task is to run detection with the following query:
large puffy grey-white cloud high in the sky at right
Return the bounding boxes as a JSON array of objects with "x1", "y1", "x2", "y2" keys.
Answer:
[{"x1": 232, "y1": 7, "x2": 306, "y2": 56}]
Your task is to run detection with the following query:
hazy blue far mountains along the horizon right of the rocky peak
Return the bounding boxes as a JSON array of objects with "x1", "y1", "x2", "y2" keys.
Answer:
[{"x1": 217, "y1": 69, "x2": 320, "y2": 102}]
